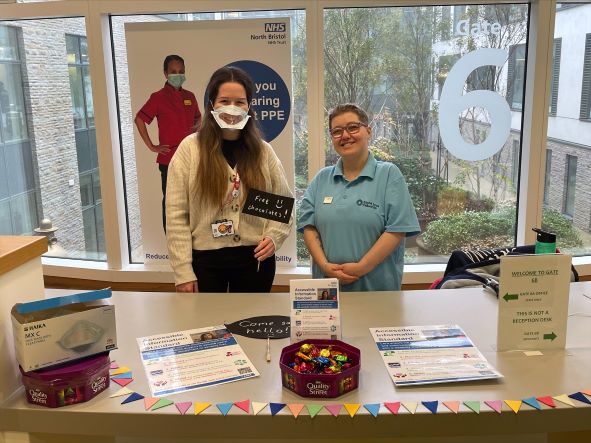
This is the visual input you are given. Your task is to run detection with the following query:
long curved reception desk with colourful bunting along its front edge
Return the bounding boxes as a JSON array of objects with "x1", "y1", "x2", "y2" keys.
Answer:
[{"x1": 0, "y1": 283, "x2": 591, "y2": 443}]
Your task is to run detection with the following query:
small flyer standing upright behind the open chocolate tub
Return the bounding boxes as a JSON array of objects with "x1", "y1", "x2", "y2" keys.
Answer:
[{"x1": 289, "y1": 278, "x2": 341, "y2": 343}]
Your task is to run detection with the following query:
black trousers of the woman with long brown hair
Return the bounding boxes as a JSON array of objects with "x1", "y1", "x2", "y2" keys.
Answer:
[{"x1": 193, "y1": 246, "x2": 275, "y2": 292}]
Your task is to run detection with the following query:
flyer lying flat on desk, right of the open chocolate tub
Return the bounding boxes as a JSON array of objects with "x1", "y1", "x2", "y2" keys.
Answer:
[{"x1": 369, "y1": 325, "x2": 503, "y2": 386}]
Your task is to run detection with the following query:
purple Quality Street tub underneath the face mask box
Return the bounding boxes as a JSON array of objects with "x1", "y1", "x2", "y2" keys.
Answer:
[{"x1": 19, "y1": 353, "x2": 110, "y2": 408}]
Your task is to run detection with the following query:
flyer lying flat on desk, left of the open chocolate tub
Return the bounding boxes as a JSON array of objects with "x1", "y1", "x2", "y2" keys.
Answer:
[{"x1": 137, "y1": 325, "x2": 259, "y2": 397}]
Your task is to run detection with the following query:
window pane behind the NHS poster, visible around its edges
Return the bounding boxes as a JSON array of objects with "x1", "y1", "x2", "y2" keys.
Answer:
[{"x1": 111, "y1": 10, "x2": 309, "y2": 266}]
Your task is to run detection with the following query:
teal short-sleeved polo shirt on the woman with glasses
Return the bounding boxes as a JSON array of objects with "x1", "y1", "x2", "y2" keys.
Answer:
[{"x1": 298, "y1": 152, "x2": 420, "y2": 291}]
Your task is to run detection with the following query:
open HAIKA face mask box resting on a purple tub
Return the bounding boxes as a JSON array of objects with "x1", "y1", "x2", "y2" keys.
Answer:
[{"x1": 11, "y1": 289, "x2": 117, "y2": 372}]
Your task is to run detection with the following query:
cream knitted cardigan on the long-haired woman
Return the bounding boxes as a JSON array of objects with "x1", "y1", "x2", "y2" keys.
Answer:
[{"x1": 166, "y1": 134, "x2": 293, "y2": 285}]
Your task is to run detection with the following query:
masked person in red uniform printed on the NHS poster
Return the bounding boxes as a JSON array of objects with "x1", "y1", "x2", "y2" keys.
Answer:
[{"x1": 135, "y1": 55, "x2": 201, "y2": 232}]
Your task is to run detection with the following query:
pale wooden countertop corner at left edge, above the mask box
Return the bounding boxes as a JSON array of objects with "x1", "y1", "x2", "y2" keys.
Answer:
[{"x1": 0, "y1": 236, "x2": 47, "y2": 275}]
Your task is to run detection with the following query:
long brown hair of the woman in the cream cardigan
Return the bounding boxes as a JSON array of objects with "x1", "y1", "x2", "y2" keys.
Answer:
[{"x1": 196, "y1": 66, "x2": 266, "y2": 206}]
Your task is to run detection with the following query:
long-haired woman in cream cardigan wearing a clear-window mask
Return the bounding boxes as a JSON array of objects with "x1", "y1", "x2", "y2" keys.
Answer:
[{"x1": 166, "y1": 66, "x2": 292, "y2": 292}]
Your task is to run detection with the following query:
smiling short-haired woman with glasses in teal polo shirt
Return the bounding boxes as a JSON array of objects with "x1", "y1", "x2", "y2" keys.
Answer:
[{"x1": 298, "y1": 103, "x2": 420, "y2": 291}]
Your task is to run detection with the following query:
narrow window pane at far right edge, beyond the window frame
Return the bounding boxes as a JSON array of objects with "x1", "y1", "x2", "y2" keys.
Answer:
[{"x1": 542, "y1": 2, "x2": 591, "y2": 255}]
